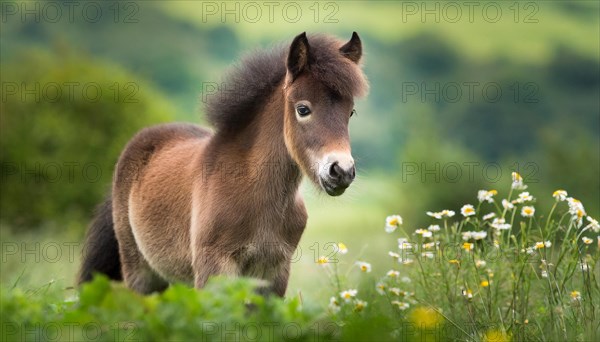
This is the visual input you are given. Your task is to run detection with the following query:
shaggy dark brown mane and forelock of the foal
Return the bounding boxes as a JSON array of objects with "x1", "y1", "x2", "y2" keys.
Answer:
[{"x1": 205, "y1": 35, "x2": 368, "y2": 133}]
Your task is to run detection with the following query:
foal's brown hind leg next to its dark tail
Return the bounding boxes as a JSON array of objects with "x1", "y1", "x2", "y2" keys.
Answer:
[{"x1": 115, "y1": 211, "x2": 169, "y2": 294}]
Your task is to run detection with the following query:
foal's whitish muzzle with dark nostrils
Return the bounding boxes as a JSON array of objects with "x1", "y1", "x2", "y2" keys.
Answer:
[{"x1": 319, "y1": 153, "x2": 356, "y2": 196}]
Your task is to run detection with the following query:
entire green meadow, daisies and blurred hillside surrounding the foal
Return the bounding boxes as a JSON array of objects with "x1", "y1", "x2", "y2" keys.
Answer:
[{"x1": 0, "y1": 1, "x2": 600, "y2": 341}]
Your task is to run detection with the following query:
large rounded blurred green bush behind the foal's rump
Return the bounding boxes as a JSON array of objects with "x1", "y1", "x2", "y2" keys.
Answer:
[{"x1": 0, "y1": 49, "x2": 173, "y2": 227}]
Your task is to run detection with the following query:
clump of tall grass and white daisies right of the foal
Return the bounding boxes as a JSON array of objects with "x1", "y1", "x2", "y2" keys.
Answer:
[{"x1": 312, "y1": 175, "x2": 600, "y2": 341}]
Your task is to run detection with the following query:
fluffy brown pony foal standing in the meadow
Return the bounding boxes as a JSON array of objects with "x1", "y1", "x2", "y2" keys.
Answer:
[{"x1": 79, "y1": 33, "x2": 368, "y2": 296}]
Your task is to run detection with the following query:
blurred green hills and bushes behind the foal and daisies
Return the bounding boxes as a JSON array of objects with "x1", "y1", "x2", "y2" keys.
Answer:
[{"x1": 0, "y1": 1, "x2": 600, "y2": 304}]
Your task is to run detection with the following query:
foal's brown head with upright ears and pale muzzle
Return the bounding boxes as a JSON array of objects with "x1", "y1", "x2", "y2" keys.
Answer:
[{"x1": 284, "y1": 32, "x2": 368, "y2": 196}]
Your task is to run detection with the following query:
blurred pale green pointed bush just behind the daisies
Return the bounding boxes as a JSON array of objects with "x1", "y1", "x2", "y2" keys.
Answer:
[{"x1": 395, "y1": 105, "x2": 488, "y2": 227}]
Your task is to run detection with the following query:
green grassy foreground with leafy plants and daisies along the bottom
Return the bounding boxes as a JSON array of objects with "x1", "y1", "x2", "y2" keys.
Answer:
[{"x1": 1, "y1": 177, "x2": 600, "y2": 341}]
